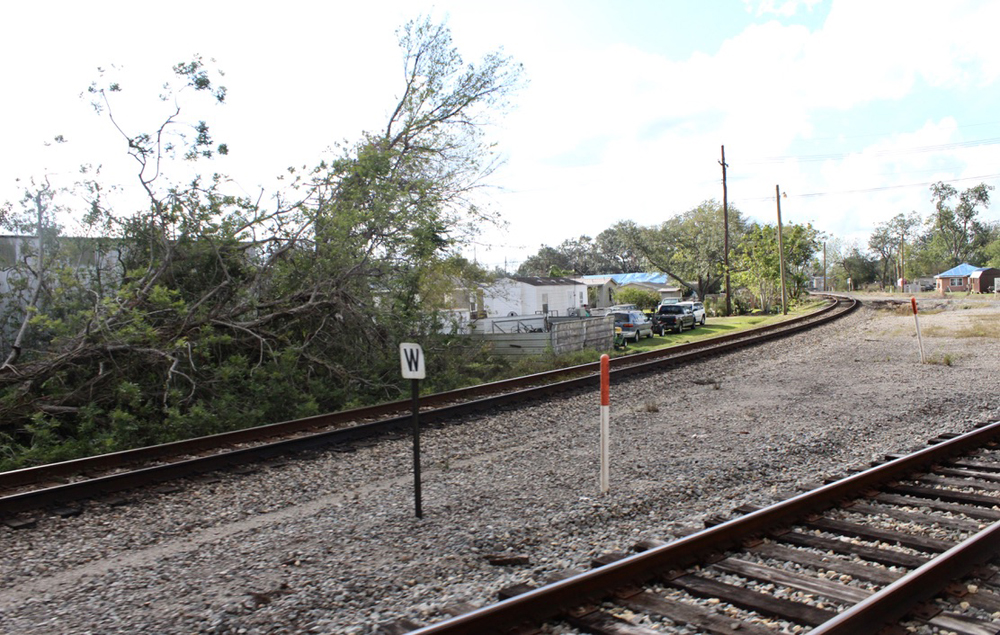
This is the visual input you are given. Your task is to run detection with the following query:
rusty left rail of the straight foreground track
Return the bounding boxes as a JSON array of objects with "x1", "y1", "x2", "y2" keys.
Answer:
[{"x1": 404, "y1": 421, "x2": 1000, "y2": 635}]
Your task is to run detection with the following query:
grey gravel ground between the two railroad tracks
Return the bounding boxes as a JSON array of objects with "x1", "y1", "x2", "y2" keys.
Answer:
[{"x1": 0, "y1": 298, "x2": 1000, "y2": 634}]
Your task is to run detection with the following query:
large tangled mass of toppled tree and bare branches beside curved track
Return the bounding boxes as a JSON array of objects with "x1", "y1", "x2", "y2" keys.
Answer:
[{"x1": 0, "y1": 20, "x2": 521, "y2": 468}]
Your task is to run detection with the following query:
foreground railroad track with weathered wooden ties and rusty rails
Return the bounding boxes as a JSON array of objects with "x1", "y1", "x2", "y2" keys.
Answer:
[{"x1": 392, "y1": 421, "x2": 1000, "y2": 635}]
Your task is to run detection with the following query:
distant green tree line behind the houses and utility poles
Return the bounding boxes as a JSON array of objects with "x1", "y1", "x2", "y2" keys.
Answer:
[{"x1": 517, "y1": 182, "x2": 1000, "y2": 300}]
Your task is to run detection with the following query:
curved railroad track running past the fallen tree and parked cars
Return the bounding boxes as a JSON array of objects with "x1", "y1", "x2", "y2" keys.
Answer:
[{"x1": 0, "y1": 296, "x2": 858, "y2": 528}]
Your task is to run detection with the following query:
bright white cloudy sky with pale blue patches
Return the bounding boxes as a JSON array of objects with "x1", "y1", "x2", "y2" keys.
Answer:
[{"x1": 0, "y1": 0, "x2": 1000, "y2": 270}]
